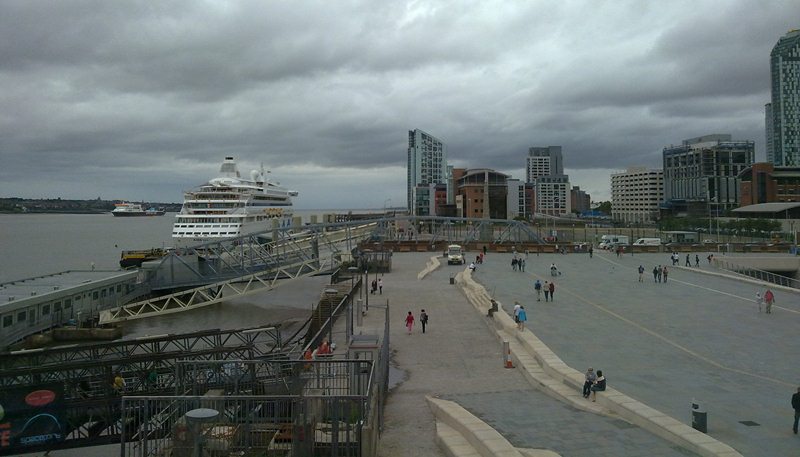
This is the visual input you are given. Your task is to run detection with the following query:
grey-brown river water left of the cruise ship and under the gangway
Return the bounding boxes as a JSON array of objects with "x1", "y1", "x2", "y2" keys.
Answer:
[{"x1": 0, "y1": 210, "x2": 358, "y2": 338}]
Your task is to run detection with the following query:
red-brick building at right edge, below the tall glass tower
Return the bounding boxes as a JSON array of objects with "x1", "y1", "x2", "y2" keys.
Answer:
[{"x1": 739, "y1": 162, "x2": 800, "y2": 206}]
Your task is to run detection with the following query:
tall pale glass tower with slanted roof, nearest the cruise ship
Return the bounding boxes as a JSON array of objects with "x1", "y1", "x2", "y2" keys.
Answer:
[{"x1": 407, "y1": 129, "x2": 447, "y2": 215}]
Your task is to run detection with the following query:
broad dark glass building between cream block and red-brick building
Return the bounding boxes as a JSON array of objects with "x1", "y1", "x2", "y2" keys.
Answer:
[{"x1": 661, "y1": 134, "x2": 755, "y2": 217}]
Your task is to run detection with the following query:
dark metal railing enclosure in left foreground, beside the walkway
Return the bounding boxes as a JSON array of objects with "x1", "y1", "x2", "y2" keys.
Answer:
[{"x1": 120, "y1": 360, "x2": 388, "y2": 457}]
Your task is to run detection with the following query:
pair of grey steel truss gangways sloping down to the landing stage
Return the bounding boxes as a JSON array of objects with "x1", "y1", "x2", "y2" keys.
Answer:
[{"x1": 100, "y1": 222, "x2": 377, "y2": 324}]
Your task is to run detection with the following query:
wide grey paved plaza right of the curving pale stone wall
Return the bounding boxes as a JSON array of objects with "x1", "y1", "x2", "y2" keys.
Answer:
[{"x1": 462, "y1": 252, "x2": 800, "y2": 456}]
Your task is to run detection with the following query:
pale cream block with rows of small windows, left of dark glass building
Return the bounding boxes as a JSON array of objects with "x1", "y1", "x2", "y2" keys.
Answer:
[{"x1": 611, "y1": 167, "x2": 664, "y2": 224}]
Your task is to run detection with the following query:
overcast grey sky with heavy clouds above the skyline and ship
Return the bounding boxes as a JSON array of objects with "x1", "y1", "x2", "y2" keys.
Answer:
[{"x1": 0, "y1": 0, "x2": 800, "y2": 209}]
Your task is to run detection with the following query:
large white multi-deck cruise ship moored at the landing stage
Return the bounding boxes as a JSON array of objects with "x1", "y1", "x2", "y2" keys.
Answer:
[{"x1": 172, "y1": 157, "x2": 297, "y2": 245}]
